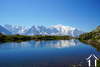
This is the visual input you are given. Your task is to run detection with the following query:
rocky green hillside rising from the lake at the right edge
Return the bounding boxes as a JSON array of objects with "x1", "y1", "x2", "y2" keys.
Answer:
[{"x1": 77, "y1": 26, "x2": 100, "y2": 52}]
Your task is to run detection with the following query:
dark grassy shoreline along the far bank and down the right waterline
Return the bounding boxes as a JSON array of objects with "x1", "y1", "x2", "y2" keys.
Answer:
[{"x1": 0, "y1": 30, "x2": 100, "y2": 67}]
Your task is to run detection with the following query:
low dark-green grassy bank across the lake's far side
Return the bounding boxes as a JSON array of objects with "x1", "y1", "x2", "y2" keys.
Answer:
[{"x1": 0, "y1": 33, "x2": 74, "y2": 42}]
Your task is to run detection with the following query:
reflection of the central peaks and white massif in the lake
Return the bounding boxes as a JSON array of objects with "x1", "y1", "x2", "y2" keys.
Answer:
[{"x1": 29, "y1": 39, "x2": 80, "y2": 48}]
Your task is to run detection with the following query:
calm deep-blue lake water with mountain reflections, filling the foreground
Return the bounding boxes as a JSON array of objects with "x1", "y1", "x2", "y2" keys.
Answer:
[{"x1": 0, "y1": 39, "x2": 100, "y2": 67}]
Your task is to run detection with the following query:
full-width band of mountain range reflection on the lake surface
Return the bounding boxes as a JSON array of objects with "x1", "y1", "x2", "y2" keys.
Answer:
[{"x1": 0, "y1": 39, "x2": 80, "y2": 50}]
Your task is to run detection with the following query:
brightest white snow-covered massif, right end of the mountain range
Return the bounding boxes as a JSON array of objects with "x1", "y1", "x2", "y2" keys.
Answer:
[{"x1": 51, "y1": 24, "x2": 85, "y2": 37}]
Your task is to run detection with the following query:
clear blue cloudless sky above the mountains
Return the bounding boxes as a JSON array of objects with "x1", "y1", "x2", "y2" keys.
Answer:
[{"x1": 0, "y1": 0, "x2": 100, "y2": 32}]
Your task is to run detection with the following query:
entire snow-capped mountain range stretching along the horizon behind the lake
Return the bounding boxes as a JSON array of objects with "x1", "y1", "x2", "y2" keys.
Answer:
[{"x1": 0, "y1": 24, "x2": 85, "y2": 37}]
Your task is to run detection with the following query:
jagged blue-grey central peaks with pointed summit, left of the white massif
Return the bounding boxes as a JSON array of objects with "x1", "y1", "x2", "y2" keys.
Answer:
[{"x1": 24, "y1": 26, "x2": 60, "y2": 36}]
